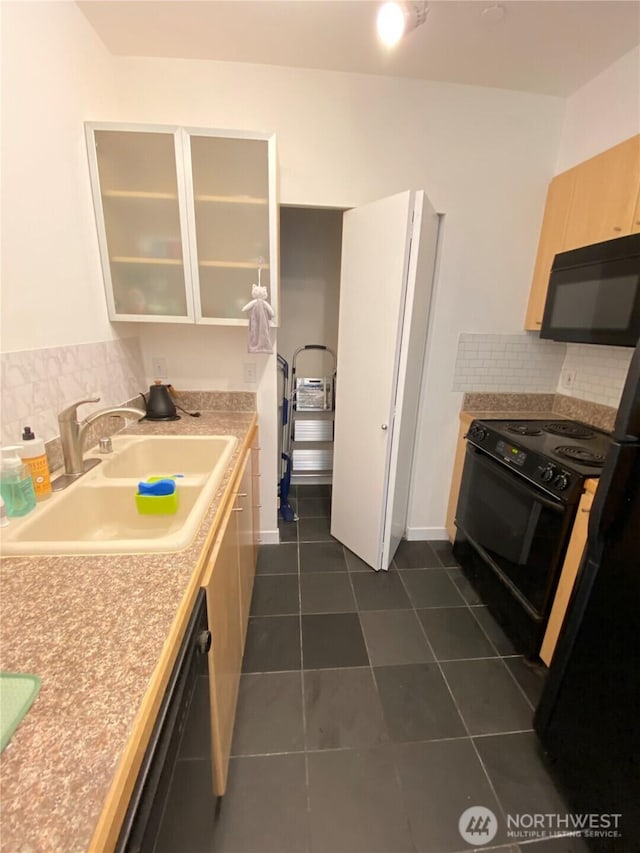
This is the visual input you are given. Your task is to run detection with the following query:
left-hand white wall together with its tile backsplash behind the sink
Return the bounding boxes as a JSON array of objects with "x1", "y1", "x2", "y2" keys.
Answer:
[{"x1": 0, "y1": 2, "x2": 149, "y2": 444}]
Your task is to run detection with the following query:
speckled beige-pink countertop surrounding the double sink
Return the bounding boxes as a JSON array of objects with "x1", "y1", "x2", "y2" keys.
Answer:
[{"x1": 0, "y1": 411, "x2": 256, "y2": 853}]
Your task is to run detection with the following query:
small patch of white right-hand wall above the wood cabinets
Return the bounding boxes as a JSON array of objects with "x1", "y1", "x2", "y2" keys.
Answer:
[{"x1": 555, "y1": 45, "x2": 640, "y2": 174}]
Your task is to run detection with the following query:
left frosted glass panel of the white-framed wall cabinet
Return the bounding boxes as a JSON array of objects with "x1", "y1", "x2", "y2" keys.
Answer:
[{"x1": 93, "y1": 129, "x2": 193, "y2": 322}]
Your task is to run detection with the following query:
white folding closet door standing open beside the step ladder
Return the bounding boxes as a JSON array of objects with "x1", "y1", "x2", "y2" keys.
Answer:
[{"x1": 331, "y1": 191, "x2": 437, "y2": 569}]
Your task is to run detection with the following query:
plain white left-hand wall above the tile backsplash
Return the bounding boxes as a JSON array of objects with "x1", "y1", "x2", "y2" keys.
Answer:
[{"x1": 1, "y1": 2, "x2": 117, "y2": 352}]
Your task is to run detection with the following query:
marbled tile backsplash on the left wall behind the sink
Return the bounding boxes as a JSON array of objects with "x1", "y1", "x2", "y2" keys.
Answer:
[{"x1": 0, "y1": 337, "x2": 146, "y2": 445}]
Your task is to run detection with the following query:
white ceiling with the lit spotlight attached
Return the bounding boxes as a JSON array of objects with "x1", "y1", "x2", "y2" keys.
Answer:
[{"x1": 78, "y1": 0, "x2": 640, "y2": 96}]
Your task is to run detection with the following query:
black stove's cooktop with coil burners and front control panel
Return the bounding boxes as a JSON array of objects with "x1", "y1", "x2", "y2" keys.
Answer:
[{"x1": 467, "y1": 419, "x2": 611, "y2": 499}]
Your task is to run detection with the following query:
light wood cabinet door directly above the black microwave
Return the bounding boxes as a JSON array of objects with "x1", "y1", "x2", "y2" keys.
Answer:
[{"x1": 564, "y1": 136, "x2": 640, "y2": 251}]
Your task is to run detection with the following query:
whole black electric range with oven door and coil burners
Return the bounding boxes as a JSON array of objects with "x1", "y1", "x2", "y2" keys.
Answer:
[{"x1": 453, "y1": 419, "x2": 610, "y2": 657}]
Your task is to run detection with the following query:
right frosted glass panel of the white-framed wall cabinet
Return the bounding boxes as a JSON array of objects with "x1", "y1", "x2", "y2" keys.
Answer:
[{"x1": 189, "y1": 134, "x2": 273, "y2": 325}]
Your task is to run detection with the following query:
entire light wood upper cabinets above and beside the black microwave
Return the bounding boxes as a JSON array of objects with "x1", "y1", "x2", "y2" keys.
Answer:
[{"x1": 524, "y1": 134, "x2": 640, "y2": 330}]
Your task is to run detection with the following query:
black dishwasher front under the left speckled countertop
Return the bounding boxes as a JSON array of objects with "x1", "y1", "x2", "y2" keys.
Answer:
[{"x1": 116, "y1": 589, "x2": 213, "y2": 853}]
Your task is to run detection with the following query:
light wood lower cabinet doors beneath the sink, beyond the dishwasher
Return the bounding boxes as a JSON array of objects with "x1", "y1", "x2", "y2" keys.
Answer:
[{"x1": 202, "y1": 432, "x2": 257, "y2": 796}]
